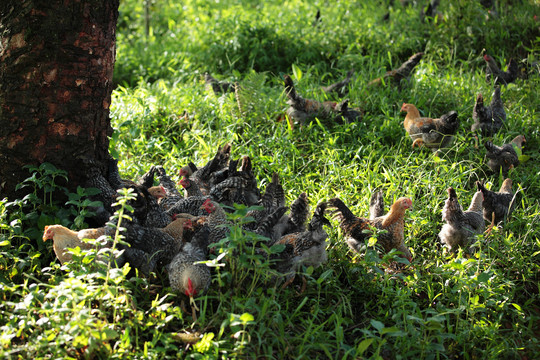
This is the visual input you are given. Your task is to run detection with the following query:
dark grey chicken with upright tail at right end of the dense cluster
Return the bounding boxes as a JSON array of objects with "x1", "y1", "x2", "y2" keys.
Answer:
[{"x1": 268, "y1": 202, "x2": 331, "y2": 292}]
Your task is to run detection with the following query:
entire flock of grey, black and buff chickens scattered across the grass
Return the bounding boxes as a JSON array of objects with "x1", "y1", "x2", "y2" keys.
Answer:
[{"x1": 43, "y1": 45, "x2": 525, "y2": 312}]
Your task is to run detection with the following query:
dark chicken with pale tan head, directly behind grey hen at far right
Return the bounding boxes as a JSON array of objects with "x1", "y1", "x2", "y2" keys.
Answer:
[{"x1": 476, "y1": 179, "x2": 516, "y2": 230}]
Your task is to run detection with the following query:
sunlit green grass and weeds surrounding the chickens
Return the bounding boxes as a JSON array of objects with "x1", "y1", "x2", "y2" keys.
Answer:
[{"x1": 0, "y1": 0, "x2": 540, "y2": 359}]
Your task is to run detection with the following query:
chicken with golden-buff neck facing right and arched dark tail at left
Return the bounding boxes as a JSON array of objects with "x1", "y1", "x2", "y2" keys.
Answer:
[{"x1": 328, "y1": 197, "x2": 412, "y2": 261}]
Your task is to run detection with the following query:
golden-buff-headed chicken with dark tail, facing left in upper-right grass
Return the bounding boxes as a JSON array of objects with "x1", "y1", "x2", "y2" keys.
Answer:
[{"x1": 401, "y1": 103, "x2": 459, "y2": 152}]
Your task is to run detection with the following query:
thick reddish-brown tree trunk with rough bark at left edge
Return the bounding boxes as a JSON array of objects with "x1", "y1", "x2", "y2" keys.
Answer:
[{"x1": 0, "y1": 0, "x2": 119, "y2": 199}]
